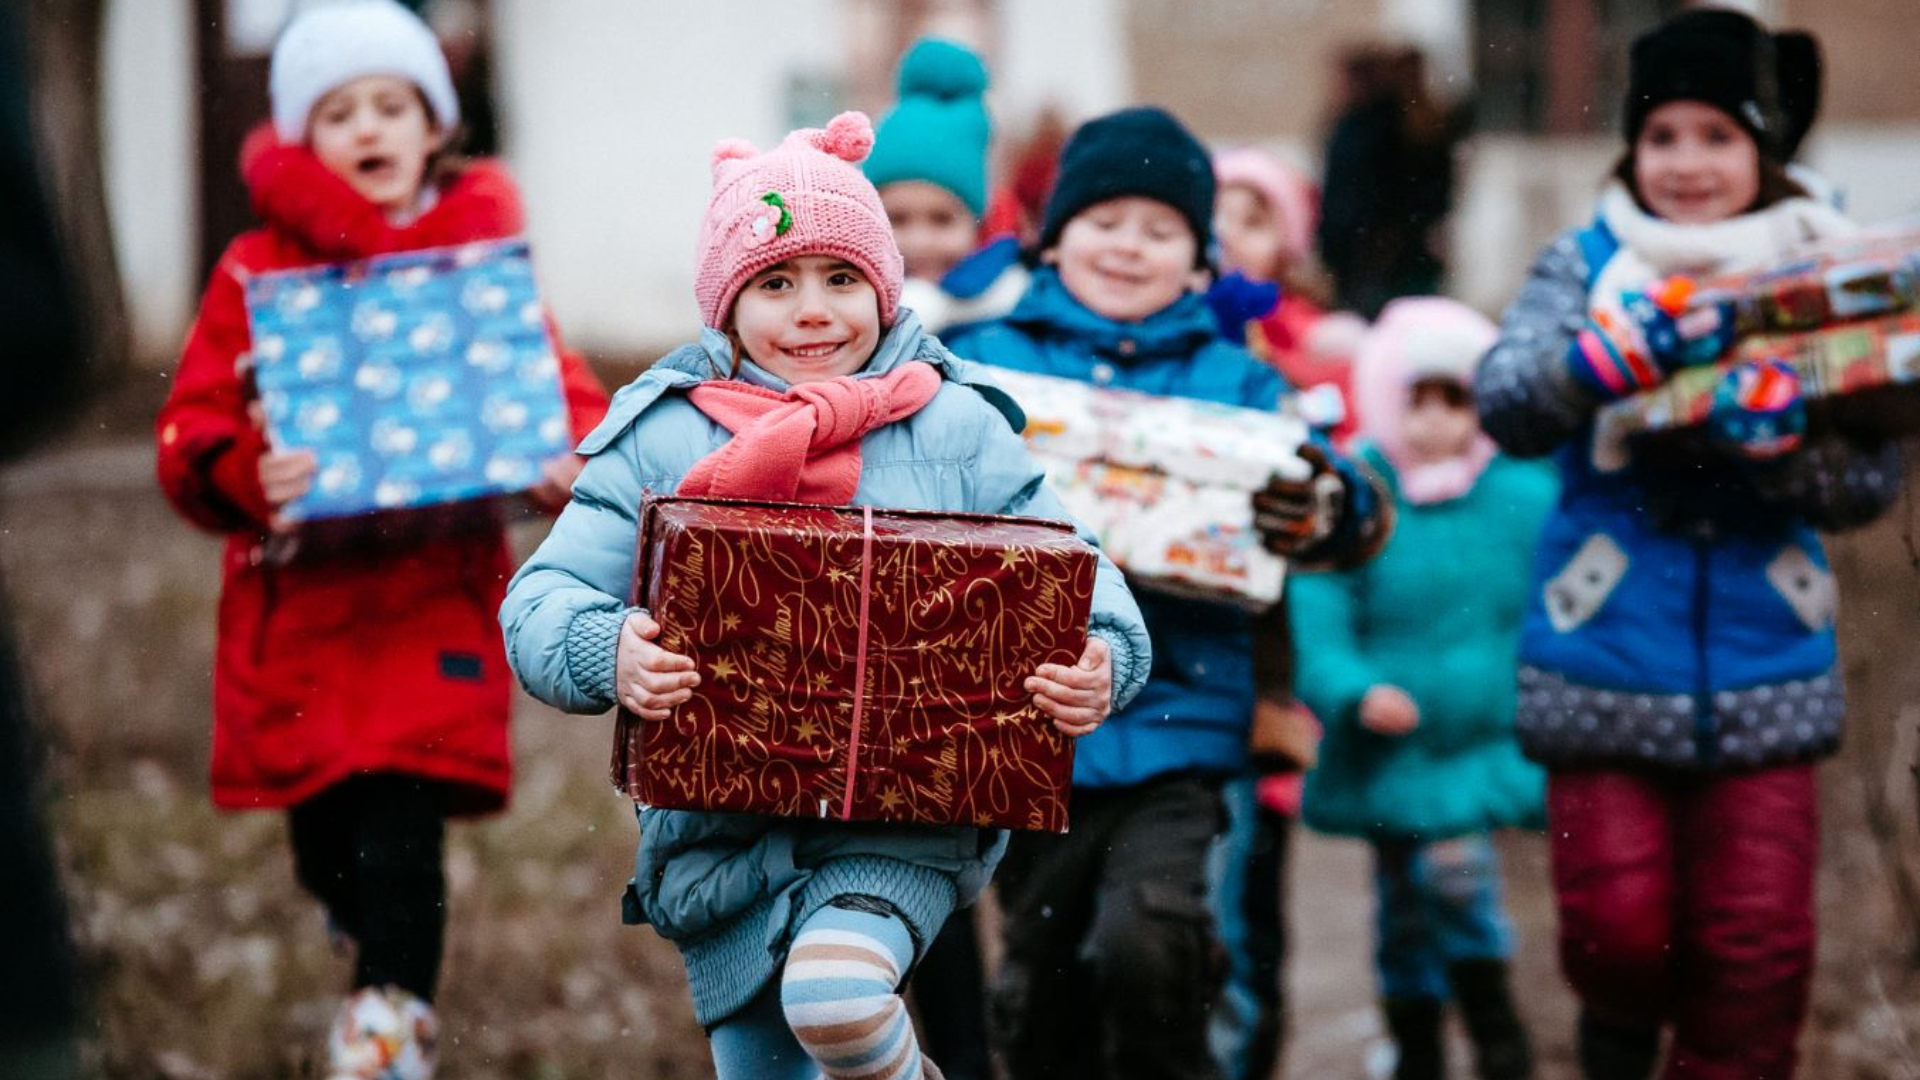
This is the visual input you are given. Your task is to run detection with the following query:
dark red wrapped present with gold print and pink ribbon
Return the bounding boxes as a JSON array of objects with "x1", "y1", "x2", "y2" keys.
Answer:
[{"x1": 612, "y1": 498, "x2": 1096, "y2": 832}]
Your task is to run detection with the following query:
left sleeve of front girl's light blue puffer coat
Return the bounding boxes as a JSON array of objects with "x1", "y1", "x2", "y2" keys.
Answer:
[{"x1": 499, "y1": 417, "x2": 641, "y2": 713}]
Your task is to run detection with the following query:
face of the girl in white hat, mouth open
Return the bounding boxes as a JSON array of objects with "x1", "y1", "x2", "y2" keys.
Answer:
[{"x1": 307, "y1": 75, "x2": 440, "y2": 213}]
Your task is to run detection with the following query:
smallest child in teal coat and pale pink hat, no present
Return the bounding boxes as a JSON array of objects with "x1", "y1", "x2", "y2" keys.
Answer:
[{"x1": 1290, "y1": 296, "x2": 1553, "y2": 1080}]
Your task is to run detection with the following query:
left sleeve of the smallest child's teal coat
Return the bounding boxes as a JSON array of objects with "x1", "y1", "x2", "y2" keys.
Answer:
[{"x1": 1286, "y1": 571, "x2": 1382, "y2": 724}]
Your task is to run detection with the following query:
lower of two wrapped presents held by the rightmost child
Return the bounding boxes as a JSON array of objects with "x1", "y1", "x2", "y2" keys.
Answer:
[{"x1": 1597, "y1": 311, "x2": 1920, "y2": 438}]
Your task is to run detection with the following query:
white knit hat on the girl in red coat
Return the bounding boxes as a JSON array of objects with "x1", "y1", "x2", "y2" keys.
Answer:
[{"x1": 267, "y1": 0, "x2": 461, "y2": 142}]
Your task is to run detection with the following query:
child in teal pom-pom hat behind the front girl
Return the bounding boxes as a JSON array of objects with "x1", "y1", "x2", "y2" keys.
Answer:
[{"x1": 864, "y1": 38, "x2": 1027, "y2": 332}]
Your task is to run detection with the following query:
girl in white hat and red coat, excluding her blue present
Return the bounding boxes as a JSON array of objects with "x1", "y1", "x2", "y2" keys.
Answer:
[{"x1": 156, "y1": 0, "x2": 607, "y2": 1080}]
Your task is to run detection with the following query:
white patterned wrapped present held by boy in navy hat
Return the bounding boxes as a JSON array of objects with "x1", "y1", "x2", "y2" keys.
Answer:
[{"x1": 993, "y1": 367, "x2": 1309, "y2": 607}]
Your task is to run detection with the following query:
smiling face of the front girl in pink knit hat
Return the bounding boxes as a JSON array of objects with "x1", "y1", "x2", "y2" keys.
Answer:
[{"x1": 733, "y1": 256, "x2": 879, "y2": 384}]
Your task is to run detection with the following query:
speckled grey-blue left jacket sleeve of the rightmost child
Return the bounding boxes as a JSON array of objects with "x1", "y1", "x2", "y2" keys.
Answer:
[{"x1": 1473, "y1": 233, "x2": 1599, "y2": 457}]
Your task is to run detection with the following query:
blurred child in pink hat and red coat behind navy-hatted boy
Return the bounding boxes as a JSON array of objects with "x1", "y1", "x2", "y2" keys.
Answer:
[{"x1": 1213, "y1": 146, "x2": 1365, "y2": 446}]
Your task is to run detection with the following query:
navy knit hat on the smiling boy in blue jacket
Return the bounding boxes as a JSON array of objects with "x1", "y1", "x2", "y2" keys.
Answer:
[{"x1": 1041, "y1": 106, "x2": 1213, "y2": 259}]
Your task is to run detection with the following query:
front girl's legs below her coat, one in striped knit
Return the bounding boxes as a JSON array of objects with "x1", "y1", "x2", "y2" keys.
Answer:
[{"x1": 712, "y1": 905, "x2": 939, "y2": 1080}]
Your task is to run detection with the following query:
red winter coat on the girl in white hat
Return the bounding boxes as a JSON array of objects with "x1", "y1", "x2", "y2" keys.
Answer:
[{"x1": 156, "y1": 140, "x2": 607, "y2": 813}]
